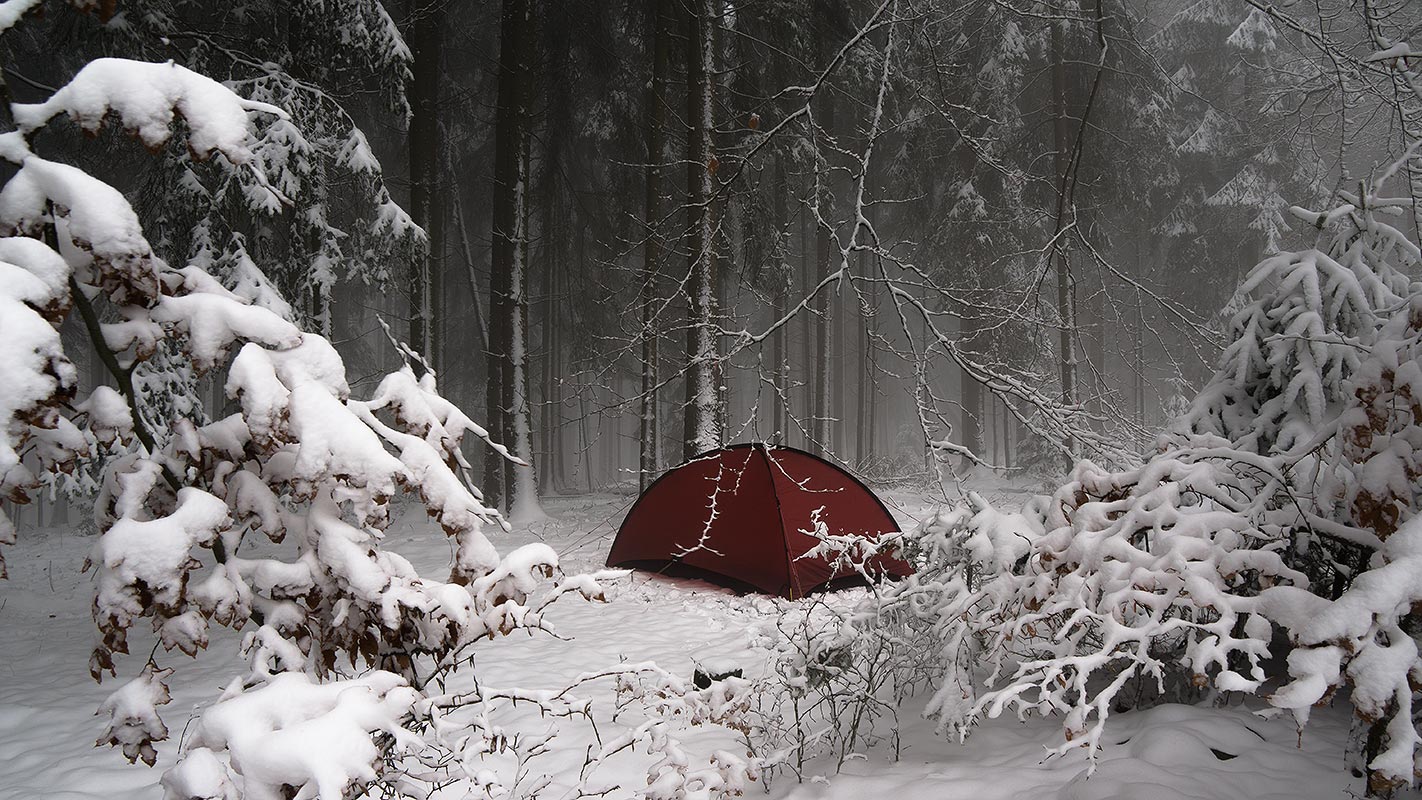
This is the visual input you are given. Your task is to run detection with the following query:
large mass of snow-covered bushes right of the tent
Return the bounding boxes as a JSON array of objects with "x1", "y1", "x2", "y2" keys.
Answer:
[{"x1": 856, "y1": 152, "x2": 1422, "y2": 794}]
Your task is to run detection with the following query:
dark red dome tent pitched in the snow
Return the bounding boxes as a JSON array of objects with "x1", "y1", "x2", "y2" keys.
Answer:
[{"x1": 607, "y1": 445, "x2": 913, "y2": 598}]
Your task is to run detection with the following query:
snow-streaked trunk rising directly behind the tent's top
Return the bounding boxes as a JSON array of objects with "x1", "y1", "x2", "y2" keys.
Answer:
[{"x1": 683, "y1": 0, "x2": 721, "y2": 458}]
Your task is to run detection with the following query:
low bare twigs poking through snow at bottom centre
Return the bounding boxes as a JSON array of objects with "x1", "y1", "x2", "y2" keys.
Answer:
[{"x1": 366, "y1": 662, "x2": 765, "y2": 800}]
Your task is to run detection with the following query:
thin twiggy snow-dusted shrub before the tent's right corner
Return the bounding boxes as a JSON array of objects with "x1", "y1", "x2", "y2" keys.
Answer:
[{"x1": 733, "y1": 494, "x2": 1042, "y2": 779}]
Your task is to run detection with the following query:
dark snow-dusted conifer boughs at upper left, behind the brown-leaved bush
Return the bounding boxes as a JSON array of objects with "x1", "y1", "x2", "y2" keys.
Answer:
[{"x1": 18, "y1": 0, "x2": 424, "y2": 335}]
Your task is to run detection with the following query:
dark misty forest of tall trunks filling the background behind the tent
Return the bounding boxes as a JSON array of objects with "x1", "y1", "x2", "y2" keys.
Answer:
[{"x1": 6, "y1": 0, "x2": 1387, "y2": 514}]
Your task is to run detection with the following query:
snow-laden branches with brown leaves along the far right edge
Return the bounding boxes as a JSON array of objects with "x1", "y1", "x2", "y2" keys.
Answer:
[{"x1": 1270, "y1": 169, "x2": 1422, "y2": 797}]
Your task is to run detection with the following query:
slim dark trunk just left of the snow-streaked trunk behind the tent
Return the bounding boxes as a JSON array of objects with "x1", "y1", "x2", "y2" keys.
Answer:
[{"x1": 637, "y1": 0, "x2": 671, "y2": 489}]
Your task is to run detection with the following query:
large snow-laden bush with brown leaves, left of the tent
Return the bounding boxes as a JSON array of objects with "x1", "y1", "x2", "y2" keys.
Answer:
[{"x1": 0, "y1": 53, "x2": 619, "y2": 799}]
